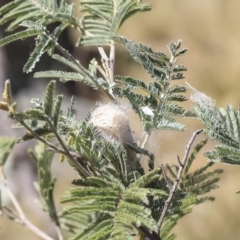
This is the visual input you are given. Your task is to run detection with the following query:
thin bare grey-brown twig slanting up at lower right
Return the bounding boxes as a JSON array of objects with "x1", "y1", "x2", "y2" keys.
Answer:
[{"x1": 157, "y1": 129, "x2": 202, "y2": 232}]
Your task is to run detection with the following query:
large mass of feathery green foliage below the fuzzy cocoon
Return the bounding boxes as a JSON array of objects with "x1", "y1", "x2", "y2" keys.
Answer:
[{"x1": 0, "y1": 76, "x2": 222, "y2": 240}]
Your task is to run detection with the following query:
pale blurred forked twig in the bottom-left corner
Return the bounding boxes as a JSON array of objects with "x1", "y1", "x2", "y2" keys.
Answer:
[{"x1": 1, "y1": 172, "x2": 54, "y2": 240}]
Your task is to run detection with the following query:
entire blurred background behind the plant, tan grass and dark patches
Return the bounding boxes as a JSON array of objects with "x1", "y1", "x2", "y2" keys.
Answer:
[{"x1": 0, "y1": 0, "x2": 240, "y2": 240}]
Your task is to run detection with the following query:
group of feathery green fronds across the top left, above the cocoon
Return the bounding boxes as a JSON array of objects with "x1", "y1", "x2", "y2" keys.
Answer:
[{"x1": 0, "y1": 0, "x2": 151, "y2": 78}]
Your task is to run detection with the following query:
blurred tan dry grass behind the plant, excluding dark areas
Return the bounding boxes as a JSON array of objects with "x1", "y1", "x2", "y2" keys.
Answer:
[{"x1": 0, "y1": 0, "x2": 240, "y2": 240}]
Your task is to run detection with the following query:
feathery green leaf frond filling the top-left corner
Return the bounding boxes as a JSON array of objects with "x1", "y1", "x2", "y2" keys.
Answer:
[{"x1": 0, "y1": 0, "x2": 80, "y2": 31}]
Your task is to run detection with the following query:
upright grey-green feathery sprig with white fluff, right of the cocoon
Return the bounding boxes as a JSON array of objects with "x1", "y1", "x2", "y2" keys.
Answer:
[{"x1": 113, "y1": 37, "x2": 194, "y2": 132}]
